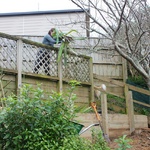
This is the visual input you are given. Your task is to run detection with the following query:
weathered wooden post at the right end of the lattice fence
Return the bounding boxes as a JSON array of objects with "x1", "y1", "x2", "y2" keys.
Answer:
[{"x1": 89, "y1": 58, "x2": 94, "y2": 105}]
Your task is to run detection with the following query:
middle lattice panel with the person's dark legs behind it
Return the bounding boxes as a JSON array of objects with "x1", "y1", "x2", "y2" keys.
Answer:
[{"x1": 23, "y1": 43, "x2": 58, "y2": 76}]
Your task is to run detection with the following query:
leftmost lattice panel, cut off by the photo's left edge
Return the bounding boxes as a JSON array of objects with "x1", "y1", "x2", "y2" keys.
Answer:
[{"x1": 0, "y1": 37, "x2": 17, "y2": 70}]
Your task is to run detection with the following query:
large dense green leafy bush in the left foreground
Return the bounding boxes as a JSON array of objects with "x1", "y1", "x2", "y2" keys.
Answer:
[{"x1": 0, "y1": 84, "x2": 110, "y2": 150}]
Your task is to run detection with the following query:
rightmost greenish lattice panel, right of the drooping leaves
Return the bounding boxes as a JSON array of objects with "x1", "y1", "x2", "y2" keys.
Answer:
[{"x1": 62, "y1": 54, "x2": 90, "y2": 82}]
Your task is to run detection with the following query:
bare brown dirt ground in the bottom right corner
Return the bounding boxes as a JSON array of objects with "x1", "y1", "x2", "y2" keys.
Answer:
[{"x1": 109, "y1": 128, "x2": 150, "y2": 150}]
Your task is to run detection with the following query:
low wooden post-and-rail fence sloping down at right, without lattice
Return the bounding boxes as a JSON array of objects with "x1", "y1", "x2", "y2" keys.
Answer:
[{"x1": 94, "y1": 75, "x2": 150, "y2": 137}]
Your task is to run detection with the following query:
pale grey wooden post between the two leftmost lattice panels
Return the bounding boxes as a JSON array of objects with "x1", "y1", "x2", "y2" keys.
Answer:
[{"x1": 16, "y1": 40, "x2": 23, "y2": 95}]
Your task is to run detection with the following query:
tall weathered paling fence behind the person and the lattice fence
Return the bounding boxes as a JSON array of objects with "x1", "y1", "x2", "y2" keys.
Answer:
[{"x1": 23, "y1": 36, "x2": 127, "y2": 81}]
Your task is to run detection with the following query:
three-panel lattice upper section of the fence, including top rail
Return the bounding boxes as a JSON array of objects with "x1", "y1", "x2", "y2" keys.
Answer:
[{"x1": 0, "y1": 33, "x2": 91, "y2": 83}]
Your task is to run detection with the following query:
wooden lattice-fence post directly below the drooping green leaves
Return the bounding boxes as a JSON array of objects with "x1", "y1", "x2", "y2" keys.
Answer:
[{"x1": 58, "y1": 58, "x2": 63, "y2": 93}]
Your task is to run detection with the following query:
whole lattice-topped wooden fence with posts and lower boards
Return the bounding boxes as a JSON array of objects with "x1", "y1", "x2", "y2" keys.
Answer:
[{"x1": 0, "y1": 33, "x2": 94, "y2": 105}]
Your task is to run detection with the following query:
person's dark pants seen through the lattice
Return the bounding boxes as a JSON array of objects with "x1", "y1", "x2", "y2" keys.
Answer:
[{"x1": 33, "y1": 49, "x2": 50, "y2": 75}]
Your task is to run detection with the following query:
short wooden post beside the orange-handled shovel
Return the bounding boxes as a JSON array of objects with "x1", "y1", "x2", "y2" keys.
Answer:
[{"x1": 101, "y1": 92, "x2": 109, "y2": 137}]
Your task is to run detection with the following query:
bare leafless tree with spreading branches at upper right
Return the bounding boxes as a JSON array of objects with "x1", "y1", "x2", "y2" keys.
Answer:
[{"x1": 71, "y1": 0, "x2": 150, "y2": 89}]
